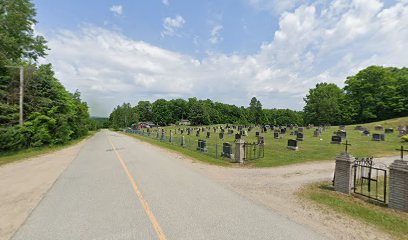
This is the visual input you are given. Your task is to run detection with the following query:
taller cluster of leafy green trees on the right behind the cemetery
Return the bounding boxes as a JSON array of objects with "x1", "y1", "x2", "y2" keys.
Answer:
[{"x1": 304, "y1": 66, "x2": 408, "y2": 125}]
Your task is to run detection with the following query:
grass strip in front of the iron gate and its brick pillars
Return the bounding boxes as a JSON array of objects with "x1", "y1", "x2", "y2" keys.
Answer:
[{"x1": 300, "y1": 182, "x2": 408, "y2": 239}]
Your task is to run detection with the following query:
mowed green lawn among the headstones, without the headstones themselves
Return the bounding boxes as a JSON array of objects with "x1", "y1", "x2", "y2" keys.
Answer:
[{"x1": 131, "y1": 117, "x2": 408, "y2": 167}]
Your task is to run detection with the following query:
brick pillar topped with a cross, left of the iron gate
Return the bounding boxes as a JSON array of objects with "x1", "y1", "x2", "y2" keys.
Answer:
[{"x1": 334, "y1": 152, "x2": 354, "y2": 194}]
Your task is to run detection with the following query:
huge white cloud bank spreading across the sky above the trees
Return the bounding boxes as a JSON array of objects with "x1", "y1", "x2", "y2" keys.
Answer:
[{"x1": 43, "y1": 0, "x2": 408, "y2": 115}]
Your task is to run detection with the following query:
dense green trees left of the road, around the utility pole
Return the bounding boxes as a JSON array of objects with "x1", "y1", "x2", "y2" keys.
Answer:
[{"x1": 0, "y1": 0, "x2": 90, "y2": 151}]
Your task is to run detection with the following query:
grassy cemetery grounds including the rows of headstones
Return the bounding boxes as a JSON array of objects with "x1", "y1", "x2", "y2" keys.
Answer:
[{"x1": 126, "y1": 118, "x2": 408, "y2": 167}]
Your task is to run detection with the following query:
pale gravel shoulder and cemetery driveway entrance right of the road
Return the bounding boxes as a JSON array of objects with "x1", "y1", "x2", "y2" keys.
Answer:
[{"x1": 135, "y1": 139, "x2": 398, "y2": 240}]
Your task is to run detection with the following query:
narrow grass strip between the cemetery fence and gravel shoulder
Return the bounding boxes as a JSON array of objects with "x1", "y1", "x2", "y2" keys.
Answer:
[{"x1": 123, "y1": 133, "x2": 232, "y2": 166}]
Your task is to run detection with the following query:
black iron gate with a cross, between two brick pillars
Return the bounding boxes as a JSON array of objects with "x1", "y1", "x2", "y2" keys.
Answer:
[{"x1": 353, "y1": 157, "x2": 388, "y2": 203}]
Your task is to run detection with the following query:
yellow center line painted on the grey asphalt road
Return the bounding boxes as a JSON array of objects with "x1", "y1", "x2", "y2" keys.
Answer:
[{"x1": 105, "y1": 134, "x2": 166, "y2": 240}]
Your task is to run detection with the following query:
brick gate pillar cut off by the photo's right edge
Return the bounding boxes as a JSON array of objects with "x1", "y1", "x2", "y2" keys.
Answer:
[{"x1": 388, "y1": 160, "x2": 408, "y2": 212}]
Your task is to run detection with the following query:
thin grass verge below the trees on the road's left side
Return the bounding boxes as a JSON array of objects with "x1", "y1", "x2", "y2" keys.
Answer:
[{"x1": 0, "y1": 131, "x2": 97, "y2": 166}]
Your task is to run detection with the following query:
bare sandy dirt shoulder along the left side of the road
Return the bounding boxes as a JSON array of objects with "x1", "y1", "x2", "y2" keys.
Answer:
[{"x1": 0, "y1": 139, "x2": 88, "y2": 240}]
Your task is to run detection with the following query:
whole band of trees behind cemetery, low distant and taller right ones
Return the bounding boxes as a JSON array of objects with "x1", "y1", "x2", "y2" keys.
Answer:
[{"x1": 109, "y1": 66, "x2": 408, "y2": 128}]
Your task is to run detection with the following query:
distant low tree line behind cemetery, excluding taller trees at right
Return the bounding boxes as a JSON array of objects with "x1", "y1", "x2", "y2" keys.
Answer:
[{"x1": 109, "y1": 97, "x2": 303, "y2": 128}]
